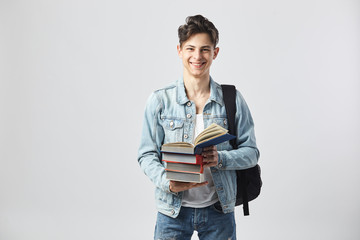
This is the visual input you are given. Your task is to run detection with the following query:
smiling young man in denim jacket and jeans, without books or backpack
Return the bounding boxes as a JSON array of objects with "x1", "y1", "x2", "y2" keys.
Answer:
[{"x1": 138, "y1": 15, "x2": 259, "y2": 240}]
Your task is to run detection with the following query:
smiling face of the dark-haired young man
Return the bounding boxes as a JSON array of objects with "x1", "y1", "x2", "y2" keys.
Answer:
[{"x1": 177, "y1": 33, "x2": 219, "y2": 79}]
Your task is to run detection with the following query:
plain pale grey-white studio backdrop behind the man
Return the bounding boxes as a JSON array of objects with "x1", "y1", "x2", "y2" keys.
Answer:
[{"x1": 0, "y1": 0, "x2": 360, "y2": 240}]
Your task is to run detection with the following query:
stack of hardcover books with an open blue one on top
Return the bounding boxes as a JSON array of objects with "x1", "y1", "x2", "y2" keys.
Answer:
[{"x1": 161, "y1": 123, "x2": 235, "y2": 183}]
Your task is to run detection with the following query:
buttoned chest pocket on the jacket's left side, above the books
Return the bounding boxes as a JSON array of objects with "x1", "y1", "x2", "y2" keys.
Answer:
[{"x1": 162, "y1": 119, "x2": 184, "y2": 143}]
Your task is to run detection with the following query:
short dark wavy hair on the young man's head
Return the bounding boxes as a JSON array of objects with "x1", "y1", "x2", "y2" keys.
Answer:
[{"x1": 178, "y1": 15, "x2": 219, "y2": 47}]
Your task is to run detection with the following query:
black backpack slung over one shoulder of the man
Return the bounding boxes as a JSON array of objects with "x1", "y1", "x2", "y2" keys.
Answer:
[{"x1": 221, "y1": 85, "x2": 262, "y2": 216}]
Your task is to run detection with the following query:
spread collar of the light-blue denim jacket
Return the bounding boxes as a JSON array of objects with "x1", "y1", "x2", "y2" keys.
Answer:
[{"x1": 176, "y1": 76, "x2": 224, "y2": 106}]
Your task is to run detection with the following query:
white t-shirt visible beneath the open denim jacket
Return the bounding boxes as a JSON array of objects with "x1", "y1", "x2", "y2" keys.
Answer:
[{"x1": 181, "y1": 114, "x2": 218, "y2": 208}]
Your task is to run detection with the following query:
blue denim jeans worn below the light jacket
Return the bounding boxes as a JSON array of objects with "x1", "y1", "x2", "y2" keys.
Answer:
[{"x1": 154, "y1": 202, "x2": 236, "y2": 240}]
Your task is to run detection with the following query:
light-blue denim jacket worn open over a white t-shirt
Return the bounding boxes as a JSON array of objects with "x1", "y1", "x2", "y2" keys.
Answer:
[{"x1": 138, "y1": 77, "x2": 259, "y2": 218}]
